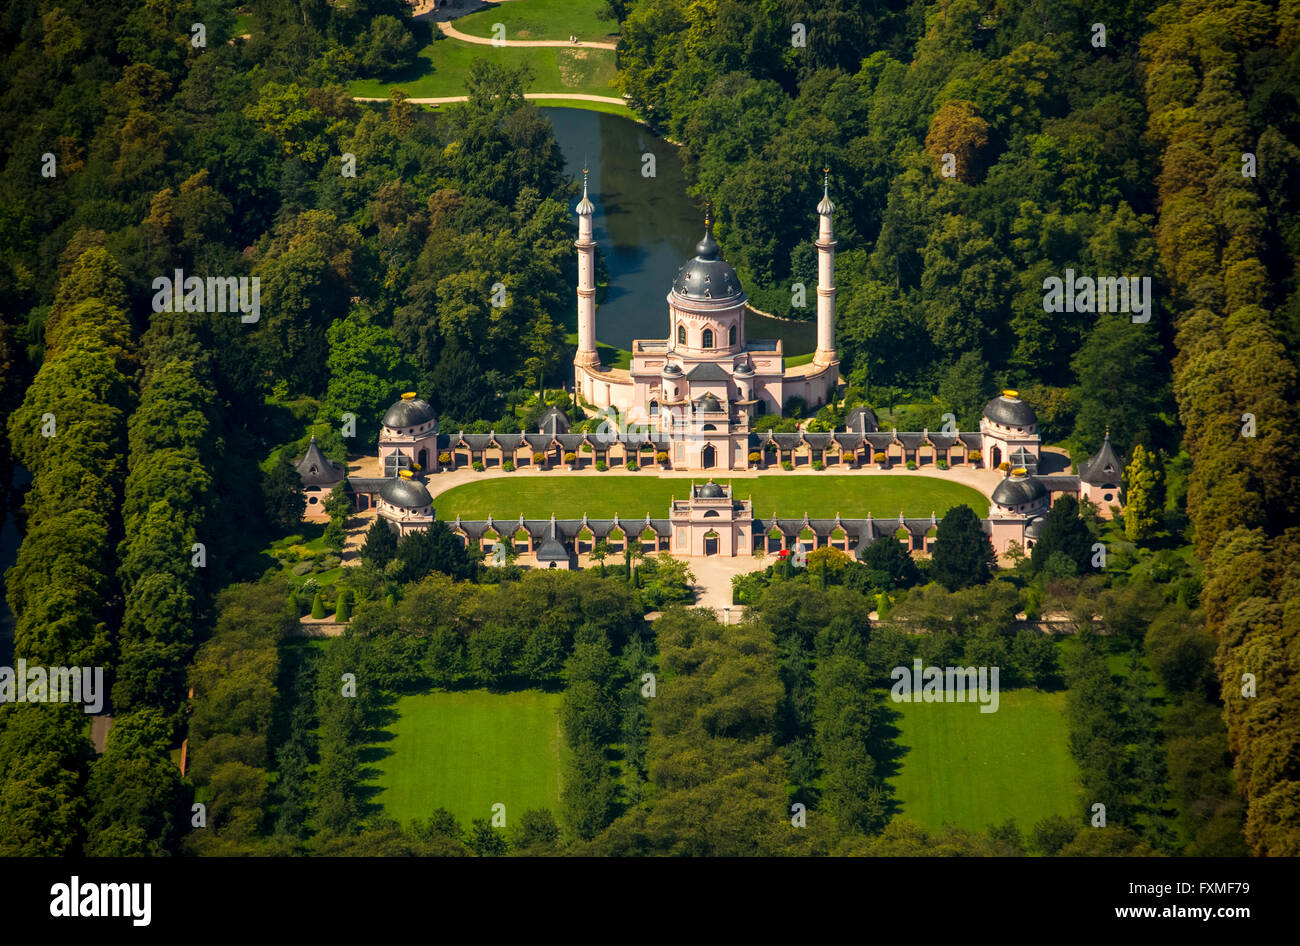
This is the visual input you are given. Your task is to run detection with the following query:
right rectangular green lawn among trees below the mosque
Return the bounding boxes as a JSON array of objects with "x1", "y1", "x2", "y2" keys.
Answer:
[{"x1": 888, "y1": 690, "x2": 1080, "y2": 832}]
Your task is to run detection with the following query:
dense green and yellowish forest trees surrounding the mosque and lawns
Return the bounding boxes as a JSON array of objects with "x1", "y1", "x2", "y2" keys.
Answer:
[{"x1": 0, "y1": 0, "x2": 1300, "y2": 856}]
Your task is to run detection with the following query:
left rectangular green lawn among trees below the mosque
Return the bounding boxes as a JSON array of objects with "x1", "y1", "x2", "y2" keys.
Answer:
[{"x1": 373, "y1": 690, "x2": 563, "y2": 828}]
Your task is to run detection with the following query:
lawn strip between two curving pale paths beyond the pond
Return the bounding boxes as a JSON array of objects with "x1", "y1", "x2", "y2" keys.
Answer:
[{"x1": 350, "y1": 39, "x2": 619, "y2": 100}]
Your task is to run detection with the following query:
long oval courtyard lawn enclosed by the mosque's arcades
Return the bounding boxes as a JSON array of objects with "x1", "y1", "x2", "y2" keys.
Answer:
[{"x1": 433, "y1": 469, "x2": 988, "y2": 520}]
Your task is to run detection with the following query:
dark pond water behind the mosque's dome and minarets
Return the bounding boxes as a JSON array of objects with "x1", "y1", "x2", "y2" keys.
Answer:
[{"x1": 541, "y1": 108, "x2": 816, "y2": 356}]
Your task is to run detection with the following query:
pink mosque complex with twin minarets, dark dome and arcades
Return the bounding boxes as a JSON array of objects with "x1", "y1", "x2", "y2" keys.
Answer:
[{"x1": 309, "y1": 182, "x2": 1123, "y2": 568}]
